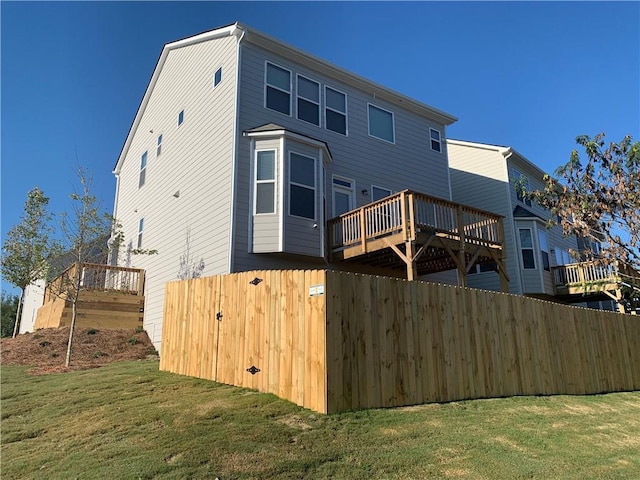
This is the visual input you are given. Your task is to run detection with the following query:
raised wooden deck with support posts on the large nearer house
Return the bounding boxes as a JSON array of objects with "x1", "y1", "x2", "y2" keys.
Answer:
[{"x1": 328, "y1": 190, "x2": 509, "y2": 291}]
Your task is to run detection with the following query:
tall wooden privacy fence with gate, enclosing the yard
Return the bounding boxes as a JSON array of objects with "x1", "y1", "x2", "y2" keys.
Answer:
[{"x1": 160, "y1": 270, "x2": 640, "y2": 413}]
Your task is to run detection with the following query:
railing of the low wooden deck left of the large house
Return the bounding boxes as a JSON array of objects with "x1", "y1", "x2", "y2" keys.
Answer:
[{"x1": 44, "y1": 263, "x2": 144, "y2": 303}]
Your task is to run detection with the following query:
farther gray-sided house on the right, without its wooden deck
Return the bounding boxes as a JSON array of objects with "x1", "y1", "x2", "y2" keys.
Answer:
[{"x1": 447, "y1": 139, "x2": 610, "y2": 300}]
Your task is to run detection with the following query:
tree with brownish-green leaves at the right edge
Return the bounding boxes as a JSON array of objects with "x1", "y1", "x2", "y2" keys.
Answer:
[{"x1": 523, "y1": 133, "x2": 640, "y2": 269}]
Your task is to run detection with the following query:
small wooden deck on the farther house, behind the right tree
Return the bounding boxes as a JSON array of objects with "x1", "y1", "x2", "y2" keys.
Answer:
[{"x1": 552, "y1": 261, "x2": 640, "y2": 313}]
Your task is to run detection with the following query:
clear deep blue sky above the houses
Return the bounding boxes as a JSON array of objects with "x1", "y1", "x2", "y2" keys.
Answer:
[{"x1": 0, "y1": 1, "x2": 640, "y2": 288}]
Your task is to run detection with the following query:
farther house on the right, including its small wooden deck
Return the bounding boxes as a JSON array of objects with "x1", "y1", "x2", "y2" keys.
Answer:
[{"x1": 446, "y1": 139, "x2": 639, "y2": 310}]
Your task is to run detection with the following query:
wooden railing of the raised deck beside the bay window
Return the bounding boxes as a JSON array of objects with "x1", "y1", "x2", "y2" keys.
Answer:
[{"x1": 328, "y1": 190, "x2": 503, "y2": 251}]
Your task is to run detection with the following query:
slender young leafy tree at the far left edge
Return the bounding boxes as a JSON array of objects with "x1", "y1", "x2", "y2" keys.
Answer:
[{"x1": 1, "y1": 187, "x2": 55, "y2": 337}]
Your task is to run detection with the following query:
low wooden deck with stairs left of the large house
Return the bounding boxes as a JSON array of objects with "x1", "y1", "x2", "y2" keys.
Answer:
[{"x1": 34, "y1": 263, "x2": 145, "y2": 329}]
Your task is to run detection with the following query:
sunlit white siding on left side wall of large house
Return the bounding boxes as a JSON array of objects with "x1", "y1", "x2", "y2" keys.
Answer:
[{"x1": 115, "y1": 37, "x2": 239, "y2": 348}]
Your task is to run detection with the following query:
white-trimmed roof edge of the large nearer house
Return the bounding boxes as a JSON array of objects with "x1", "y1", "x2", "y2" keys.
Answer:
[{"x1": 113, "y1": 22, "x2": 458, "y2": 174}]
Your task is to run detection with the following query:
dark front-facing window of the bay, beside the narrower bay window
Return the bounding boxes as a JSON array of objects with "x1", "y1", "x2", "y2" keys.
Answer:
[{"x1": 289, "y1": 152, "x2": 316, "y2": 220}]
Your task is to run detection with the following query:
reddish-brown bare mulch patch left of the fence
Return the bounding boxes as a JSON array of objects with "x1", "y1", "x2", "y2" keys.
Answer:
[{"x1": 0, "y1": 327, "x2": 157, "y2": 374}]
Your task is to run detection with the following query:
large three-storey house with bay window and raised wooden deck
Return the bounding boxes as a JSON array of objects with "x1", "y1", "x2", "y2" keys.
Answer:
[{"x1": 111, "y1": 23, "x2": 504, "y2": 346}]
